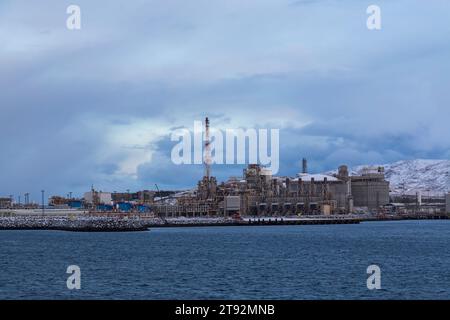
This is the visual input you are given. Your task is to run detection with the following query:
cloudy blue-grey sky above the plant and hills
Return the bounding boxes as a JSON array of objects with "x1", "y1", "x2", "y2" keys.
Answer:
[{"x1": 0, "y1": 0, "x2": 450, "y2": 199}]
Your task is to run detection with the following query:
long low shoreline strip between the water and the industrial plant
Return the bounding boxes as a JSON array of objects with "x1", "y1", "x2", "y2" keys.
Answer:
[{"x1": 0, "y1": 214, "x2": 450, "y2": 232}]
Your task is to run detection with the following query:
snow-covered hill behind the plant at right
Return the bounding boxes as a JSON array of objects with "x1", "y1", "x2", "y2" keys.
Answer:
[{"x1": 330, "y1": 159, "x2": 450, "y2": 195}]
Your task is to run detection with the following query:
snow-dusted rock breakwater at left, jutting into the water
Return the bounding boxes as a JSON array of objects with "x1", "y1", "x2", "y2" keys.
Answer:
[{"x1": 0, "y1": 216, "x2": 148, "y2": 232}]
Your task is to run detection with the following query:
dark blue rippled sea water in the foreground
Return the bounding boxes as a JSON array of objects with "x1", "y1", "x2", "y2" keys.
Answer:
[{"x1": 0, "y1": 221, "x2": 450, "y2": 299}]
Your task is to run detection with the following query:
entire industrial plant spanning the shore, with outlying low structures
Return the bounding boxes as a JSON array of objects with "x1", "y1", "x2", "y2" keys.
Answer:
[{"x1": 0, "y1": 118, "x2": 450, "y2": 218}]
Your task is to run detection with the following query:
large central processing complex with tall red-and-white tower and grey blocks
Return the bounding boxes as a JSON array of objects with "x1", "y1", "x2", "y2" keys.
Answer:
[{"x1": 155, "y1": 118, "x2": 389, "y2": 217}]
